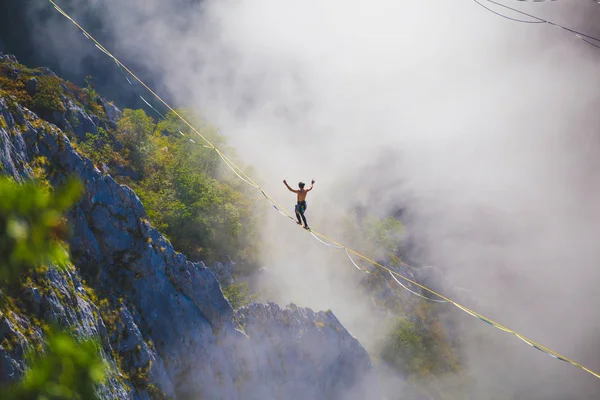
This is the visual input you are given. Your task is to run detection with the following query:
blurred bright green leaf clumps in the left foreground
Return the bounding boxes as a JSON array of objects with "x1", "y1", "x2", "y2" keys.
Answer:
[{"x1": 0, "y1": 177, "x2": 105, "y2": 400}]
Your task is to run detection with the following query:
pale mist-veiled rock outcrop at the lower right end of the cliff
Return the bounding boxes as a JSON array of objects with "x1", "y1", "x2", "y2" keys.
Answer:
[{"x1": 236, "y1": 303, "x2": 377, "y2": 399}]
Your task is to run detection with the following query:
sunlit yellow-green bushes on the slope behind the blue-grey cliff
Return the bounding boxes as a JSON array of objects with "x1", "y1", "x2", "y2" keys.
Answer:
[{"x1": 77, "y1": 109, "x2": 260, "y2": 271}]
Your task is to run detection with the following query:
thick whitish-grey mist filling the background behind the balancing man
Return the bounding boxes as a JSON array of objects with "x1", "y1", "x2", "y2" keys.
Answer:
[{"x1": 29, "y1": 0, "x2": 600, "y2": 400}]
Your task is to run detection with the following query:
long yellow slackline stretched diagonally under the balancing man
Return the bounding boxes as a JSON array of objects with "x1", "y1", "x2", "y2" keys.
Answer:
[{"x1": 48, "y1": 0, "x2": 600, "y2": 378}]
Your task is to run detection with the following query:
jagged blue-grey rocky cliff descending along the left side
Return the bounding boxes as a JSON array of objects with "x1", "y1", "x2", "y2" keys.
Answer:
[{"x1": 0, "y1": 54, "x2": 375, "y2": 399}]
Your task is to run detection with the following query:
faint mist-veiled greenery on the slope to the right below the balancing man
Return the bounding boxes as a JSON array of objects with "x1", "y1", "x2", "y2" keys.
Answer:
[{"x1": 345, "y1": 209, "x2": 460, "y2": 398}]
